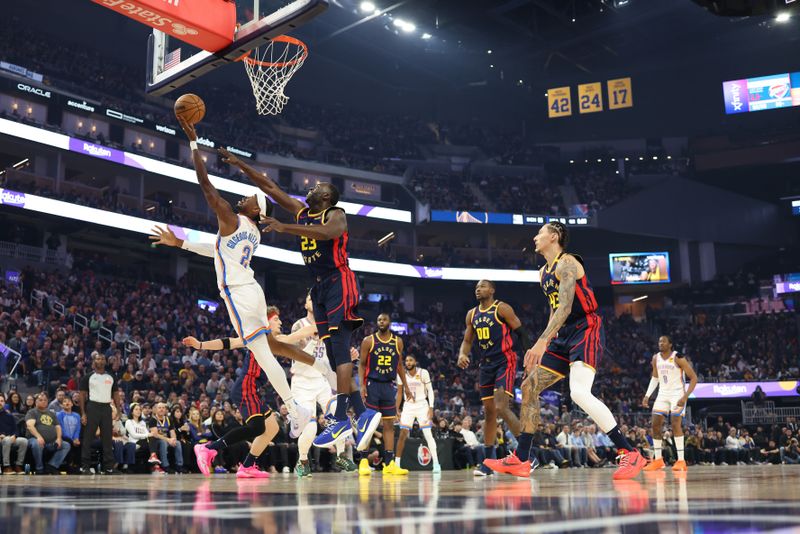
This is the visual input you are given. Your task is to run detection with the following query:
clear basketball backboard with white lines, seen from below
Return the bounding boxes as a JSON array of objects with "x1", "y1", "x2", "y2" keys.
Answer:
[{"x1": 146, "y1": 0, "x2": 328, "y2": 95}]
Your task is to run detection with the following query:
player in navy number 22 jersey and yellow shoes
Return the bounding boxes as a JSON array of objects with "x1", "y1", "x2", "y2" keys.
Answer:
[{"x1": 358, "y1": 313, "x2": 411, "y2": 475}]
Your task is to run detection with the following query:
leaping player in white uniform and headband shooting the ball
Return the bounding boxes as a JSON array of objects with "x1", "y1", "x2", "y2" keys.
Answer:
[{"x1": 150, "y1": 120, "x2": 311, "y2": 437}]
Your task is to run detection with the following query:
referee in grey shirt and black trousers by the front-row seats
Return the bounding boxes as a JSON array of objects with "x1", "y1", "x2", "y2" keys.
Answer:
[{"x1": 80, "y1": 352, "x2": 117, "y2": 475}]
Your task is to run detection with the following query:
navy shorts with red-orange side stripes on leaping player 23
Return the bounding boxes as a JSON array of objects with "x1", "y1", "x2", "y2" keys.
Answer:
[{"x1": 311, "y1": 268, "x2": 364, "y2": 370}]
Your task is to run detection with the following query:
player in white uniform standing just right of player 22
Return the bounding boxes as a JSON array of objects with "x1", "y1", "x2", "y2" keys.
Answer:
[{"x1": 394, "y1": 354, "x2": 442, "y2": 473}]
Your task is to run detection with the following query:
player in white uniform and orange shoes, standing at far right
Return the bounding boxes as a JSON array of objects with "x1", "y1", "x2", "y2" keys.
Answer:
[{"x1": 642, "y1": 336, "x2": 697, "y2": 471}]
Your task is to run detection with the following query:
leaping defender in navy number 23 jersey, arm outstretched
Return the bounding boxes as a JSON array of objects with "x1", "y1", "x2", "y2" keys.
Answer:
[{"x1": 221, "y1": 155, "x2": 381, "y2": 456}]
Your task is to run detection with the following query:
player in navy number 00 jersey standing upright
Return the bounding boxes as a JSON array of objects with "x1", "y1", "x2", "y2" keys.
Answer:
[{"x1": 457, "y1": 280, "x2": 531, "y2": 476}]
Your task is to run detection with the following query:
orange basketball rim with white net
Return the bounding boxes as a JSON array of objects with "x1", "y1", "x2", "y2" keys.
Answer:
[{"x1": 239, "y1": 35, "x2": 308, "y2": 115}]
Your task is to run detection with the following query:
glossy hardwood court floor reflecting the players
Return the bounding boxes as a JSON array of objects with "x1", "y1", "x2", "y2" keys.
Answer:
[{"x1": 0, "y1": 465, "x2": 800, "y2": 534}]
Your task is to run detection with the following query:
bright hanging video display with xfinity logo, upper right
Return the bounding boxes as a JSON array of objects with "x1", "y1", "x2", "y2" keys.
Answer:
[{"x1": 722, "y1": 72, "x2": 800, "y2": 115}]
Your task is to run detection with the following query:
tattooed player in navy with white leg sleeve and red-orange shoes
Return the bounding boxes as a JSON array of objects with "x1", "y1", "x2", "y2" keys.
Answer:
[{"x1": 490, "y1": 222, "x2": 645, "y2": 479}]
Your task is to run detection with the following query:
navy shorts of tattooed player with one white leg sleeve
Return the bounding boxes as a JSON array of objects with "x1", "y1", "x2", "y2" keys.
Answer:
[{"x1": 541, "y1": 315, "x2": 606, "y2": 378}]
